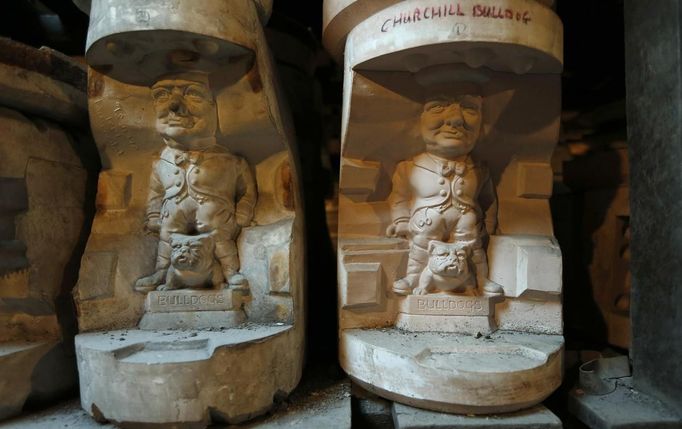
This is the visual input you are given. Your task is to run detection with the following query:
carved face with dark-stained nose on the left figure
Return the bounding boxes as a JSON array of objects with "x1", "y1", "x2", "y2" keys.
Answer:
[{"x1": 152, "y1": 79, "x2": 217, "y2": 149}]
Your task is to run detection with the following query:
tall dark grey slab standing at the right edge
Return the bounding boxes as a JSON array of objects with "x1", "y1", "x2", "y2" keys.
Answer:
[{"x1": 624, "y1": 0, "x2": 682, "y2": 414}]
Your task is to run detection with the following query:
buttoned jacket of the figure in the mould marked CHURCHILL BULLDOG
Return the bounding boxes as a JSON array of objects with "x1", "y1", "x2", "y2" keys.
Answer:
[{"x1": 389, "y1": 152, "x2": 496, "y2": 227}]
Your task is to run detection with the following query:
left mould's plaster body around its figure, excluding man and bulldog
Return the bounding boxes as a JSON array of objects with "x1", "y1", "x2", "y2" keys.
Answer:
[{"x1": 71, "y1": 0, "x2": 305, "y2": 427}]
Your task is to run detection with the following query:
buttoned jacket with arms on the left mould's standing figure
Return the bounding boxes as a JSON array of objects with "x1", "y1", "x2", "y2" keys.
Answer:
[{"x1": 147, "y1": 145, "x2": 258, "y2": 226}]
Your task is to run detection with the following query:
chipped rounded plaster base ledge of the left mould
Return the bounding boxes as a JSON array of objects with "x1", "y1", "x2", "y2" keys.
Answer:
[{"x1": 76, "y1": 324, "x2": 301, "y2": 426}]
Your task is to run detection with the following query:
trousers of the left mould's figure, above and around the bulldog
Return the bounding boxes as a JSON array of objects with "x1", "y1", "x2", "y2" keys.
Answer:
[{"x1": 156, "y1": 196, "x2": 239, "y2": 280}]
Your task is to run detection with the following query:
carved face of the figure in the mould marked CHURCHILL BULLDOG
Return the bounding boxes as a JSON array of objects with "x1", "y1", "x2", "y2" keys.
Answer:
[{"x1": 421, "y1": 95, "x2": 483, "y2": 158}]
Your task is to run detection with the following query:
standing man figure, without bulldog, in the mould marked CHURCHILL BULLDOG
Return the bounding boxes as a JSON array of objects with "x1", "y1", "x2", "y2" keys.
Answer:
[{"x1": 386, "y1": 91, "x2": 502, "y2": 295}]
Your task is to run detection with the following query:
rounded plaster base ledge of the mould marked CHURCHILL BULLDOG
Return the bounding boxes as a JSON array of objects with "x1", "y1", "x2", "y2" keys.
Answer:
[{"x1": 340, "y1": 329, "x2": 563, "y2": 414}]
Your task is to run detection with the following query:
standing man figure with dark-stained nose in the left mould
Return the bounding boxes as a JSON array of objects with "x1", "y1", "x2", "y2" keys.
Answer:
[{"x1": 135, "y1": 73, "x2": 257, "y2": 292}]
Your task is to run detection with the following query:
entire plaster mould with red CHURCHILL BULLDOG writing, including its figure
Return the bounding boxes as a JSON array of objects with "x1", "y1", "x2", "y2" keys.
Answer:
[{"x1": 324, "y1": 0, "x2": 564, "y2": 414}]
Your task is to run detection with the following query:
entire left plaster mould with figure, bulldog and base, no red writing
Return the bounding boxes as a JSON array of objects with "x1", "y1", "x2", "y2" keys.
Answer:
[{"x1": 75, "y1": 0, "x2": 304, "y2": 427}]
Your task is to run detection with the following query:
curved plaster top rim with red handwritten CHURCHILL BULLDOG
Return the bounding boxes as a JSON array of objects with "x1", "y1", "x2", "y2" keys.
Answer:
[{"x1": 345, "y1": 0, "x2": 563, "y2": 74}]
